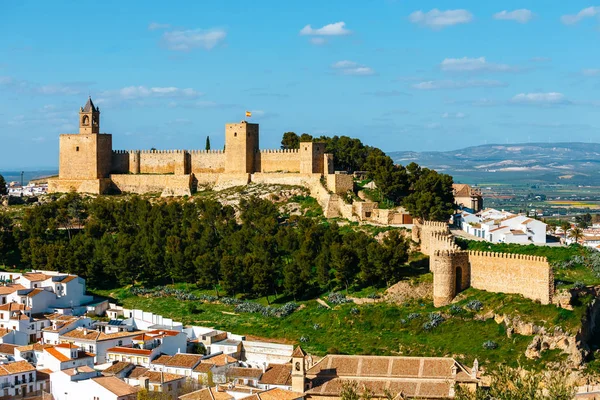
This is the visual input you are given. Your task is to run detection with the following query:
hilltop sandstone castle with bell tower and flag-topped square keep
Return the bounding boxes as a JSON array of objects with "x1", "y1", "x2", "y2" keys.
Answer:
[{"x1": 49, "y1": 98, "x2": 353, "y2": 197}]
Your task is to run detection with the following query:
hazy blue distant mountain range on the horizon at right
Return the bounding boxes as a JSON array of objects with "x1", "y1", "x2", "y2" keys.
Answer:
[{"x1": 388, "y1": 142, "x2": 600, "y2": 185}]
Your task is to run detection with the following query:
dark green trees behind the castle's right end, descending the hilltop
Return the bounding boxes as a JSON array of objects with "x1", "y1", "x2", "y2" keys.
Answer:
[{"x1": 281, "y1": 132, "x2": 454, "y2": 221}]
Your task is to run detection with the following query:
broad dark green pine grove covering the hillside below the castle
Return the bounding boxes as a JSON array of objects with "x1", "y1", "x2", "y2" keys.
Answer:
[{"x1": 0, "y1": 194, "x2": 409, "y2": 296}]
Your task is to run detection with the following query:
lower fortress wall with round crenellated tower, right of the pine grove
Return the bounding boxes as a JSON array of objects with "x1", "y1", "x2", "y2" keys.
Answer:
[{"x1": 412, "y1": 221, "x2": 554, "y2": 307}]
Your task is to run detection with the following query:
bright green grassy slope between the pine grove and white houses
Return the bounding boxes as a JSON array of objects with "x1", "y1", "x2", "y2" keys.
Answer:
[{"x1": 96, "y1": 282, "x2": 581, "y2": 368}]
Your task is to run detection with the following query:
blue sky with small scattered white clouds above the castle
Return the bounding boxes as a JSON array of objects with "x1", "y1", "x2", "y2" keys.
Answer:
[{"x1": 0, "y1": 0, "x2": 600, "y2": 169}]
